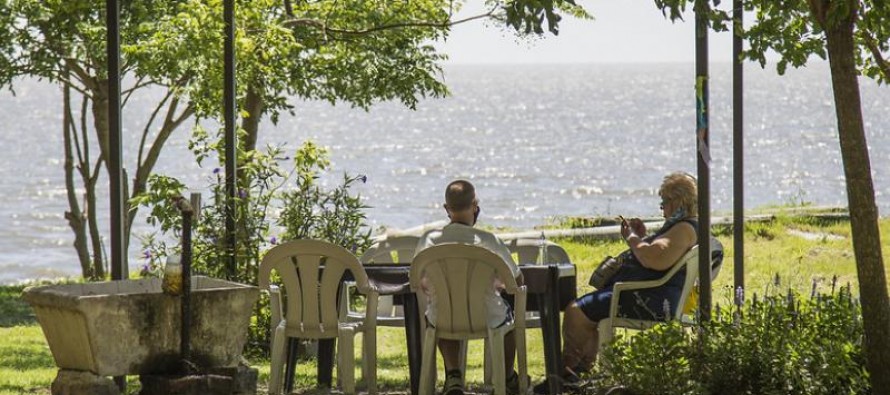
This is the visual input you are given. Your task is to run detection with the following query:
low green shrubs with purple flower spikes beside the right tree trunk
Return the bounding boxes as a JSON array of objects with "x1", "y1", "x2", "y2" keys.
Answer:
[{"x1": 600, "y1": 285, "x2": 870, "y2": 395}]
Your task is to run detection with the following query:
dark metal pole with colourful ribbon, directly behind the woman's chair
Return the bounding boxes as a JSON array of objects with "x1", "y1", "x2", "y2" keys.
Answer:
[{"x1": 695, "y1": 0, "x2": 711, "y2": 322}]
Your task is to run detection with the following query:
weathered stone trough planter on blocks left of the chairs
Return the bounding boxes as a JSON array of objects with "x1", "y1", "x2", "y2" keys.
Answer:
[{"x1": 24, "y1": 276, "x2": 259, "y2": 376}]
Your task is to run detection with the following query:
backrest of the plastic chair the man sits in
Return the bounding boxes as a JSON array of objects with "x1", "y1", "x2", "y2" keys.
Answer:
[{"x1": 409, "y1": 244, "x2": 518, "y2": 334}]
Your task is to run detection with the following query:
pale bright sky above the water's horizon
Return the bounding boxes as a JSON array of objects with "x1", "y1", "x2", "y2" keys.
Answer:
[{"x1": 440, "y1": 0, "x2": 732, "y2": 64}]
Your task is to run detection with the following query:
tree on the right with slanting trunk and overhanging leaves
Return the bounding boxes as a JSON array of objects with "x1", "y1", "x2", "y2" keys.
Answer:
[{"x1": 656, "y1": 0, "x2": 890, "y2": 394}]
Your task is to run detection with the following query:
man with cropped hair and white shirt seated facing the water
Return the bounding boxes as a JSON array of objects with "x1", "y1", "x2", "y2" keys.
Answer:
[{"x1": 416, "y1": 180, "x2": 522, "y2": 395}]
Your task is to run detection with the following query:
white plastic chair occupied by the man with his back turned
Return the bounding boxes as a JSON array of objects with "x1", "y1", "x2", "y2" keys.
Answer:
[{"x1": 409, "y1": 244, "x2": 528, "y2": 395}]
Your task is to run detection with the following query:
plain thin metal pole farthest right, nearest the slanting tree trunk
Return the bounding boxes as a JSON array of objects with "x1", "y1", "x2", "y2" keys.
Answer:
[{"x1": 732, "y1": 0, "x2": 745, "y2": 296}]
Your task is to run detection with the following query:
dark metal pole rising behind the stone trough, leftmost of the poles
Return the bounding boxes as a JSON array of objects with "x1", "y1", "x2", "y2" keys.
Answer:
[{"x1": 105, "y1": 0, "x2": 129, "y2": 280}]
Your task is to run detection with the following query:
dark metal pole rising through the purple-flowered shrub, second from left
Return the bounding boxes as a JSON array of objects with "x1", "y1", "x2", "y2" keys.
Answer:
[{"x1": 223, "y1": 0, "x2": 238, "y2": 280}]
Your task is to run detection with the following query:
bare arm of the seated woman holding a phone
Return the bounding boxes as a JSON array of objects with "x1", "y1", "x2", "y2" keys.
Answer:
[{"x1": 626, "y1": 222, "x2": 698, "y2": 270}]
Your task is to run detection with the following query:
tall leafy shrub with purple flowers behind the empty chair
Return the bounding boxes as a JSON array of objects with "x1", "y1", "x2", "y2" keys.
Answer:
[{"x1": 133, "y1": 130, "x2": 371, "y2": 355}]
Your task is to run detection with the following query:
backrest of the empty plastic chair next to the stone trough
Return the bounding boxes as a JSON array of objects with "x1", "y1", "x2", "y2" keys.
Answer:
[{"x1": 259, "y1": 240, "x2": 371, "y2": 334}]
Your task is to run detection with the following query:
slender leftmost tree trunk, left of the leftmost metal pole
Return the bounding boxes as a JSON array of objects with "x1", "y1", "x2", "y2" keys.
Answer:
[{"x1": 62, "y1": 79, "x2": 92, "y2": 278}]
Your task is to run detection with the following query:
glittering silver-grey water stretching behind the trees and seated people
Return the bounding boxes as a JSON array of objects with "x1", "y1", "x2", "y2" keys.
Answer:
[{"x1": 0, "y1": 63, "x2": 890, "y2": 283}]
